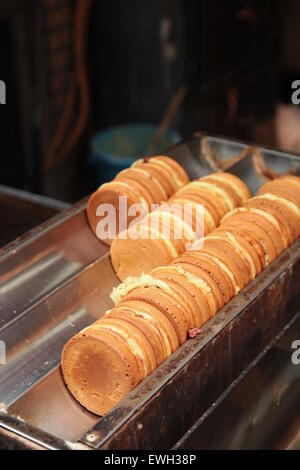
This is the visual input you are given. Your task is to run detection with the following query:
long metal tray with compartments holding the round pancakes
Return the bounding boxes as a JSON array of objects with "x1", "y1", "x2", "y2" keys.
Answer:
[{"x1": 0, "y1": 133, "x2": 300, "y2": 449}]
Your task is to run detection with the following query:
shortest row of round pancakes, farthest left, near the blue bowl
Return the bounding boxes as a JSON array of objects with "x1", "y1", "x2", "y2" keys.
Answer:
[{"x1": 87, "y1": 156, "x2": 189, "y2": 245}]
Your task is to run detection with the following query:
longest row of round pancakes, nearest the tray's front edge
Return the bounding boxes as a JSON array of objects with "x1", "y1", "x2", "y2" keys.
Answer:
[{"x1": 62, "y1": 176, "x2": 300, "y2": 415}]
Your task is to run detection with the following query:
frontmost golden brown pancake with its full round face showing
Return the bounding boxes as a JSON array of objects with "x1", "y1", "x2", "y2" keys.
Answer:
[{"x1": 61, "y1": 325, "x2": 142, "y2": 415}]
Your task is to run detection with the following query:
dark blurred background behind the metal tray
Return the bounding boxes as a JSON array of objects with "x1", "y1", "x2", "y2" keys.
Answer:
[{"x1": 0, "y1": 0, "x2": 300, "y2": 202}]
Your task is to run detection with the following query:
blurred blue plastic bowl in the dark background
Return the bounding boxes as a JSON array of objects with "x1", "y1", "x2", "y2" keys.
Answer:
[{"x1": 88, "y1": 124, "x2": 180, "y2": 184}]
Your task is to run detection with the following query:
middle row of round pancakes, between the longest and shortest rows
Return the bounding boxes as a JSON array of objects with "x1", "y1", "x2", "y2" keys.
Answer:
[{"x1": 110, "y1": 173, "x2": 251, "y2": 281}]
